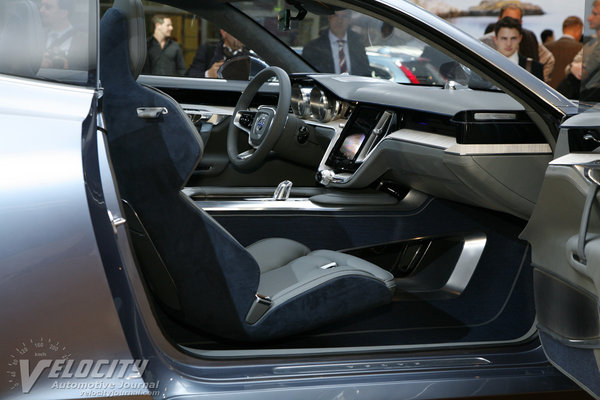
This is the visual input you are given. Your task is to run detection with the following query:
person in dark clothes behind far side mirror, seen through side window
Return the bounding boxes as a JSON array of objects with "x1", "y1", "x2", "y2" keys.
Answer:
[{"x1": 186, "y1": 29, "x2": 250, "y2": 78}]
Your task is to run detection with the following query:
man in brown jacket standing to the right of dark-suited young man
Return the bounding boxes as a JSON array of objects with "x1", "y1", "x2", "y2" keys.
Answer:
[{"x1": 546, "y1": 16, "x2": 583, "y2": 89}]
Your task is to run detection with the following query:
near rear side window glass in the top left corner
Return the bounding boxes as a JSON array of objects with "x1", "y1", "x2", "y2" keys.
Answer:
[{"x1": 0, "y1": 0, "x2": 97, "y2": 86}]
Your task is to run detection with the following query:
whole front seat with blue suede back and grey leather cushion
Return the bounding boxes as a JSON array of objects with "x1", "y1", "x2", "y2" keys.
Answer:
[{"x1": 100, "y1": 0, "x2": 394, "y2": 341}]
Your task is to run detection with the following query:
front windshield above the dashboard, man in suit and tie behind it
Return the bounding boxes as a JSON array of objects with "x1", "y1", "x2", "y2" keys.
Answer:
[{"x1": 233, "y1": 0, "x2": 490, "y2": 89}]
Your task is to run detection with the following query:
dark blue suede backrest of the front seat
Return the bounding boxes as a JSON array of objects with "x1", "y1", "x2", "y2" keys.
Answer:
[{"x1": 100, "y1": 9, "x2": 260, "y2": 338}]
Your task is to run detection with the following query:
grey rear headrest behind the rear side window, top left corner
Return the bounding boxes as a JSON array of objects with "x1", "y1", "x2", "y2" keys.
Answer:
[{"x1": 0, "y1": 0, "x2": 45, "y2": 77}]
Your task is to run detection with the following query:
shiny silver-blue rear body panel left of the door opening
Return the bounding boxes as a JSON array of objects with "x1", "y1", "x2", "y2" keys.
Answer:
[{"x1": 0, "y1": 76, "x2": 144, "y2": 399}]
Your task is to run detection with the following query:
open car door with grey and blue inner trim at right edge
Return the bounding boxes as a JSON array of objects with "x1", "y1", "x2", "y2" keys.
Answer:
[{"x1": 521, "y1": 112, "x2": 600, "y2": 398}]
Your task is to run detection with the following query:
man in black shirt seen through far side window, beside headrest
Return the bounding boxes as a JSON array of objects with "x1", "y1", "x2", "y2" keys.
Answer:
[{"x1": 143, "y1": 14, "x2": 185, "y2": 75}]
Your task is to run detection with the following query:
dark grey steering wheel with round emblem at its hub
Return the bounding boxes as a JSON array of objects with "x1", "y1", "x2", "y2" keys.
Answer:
[{"x1": 227, "y1": 67, "x2": 292, "y2": 170}]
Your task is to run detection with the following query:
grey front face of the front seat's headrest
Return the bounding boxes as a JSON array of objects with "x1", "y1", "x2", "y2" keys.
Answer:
[{"x1": 112, "y1": 0, "x2": 146, "y2": 79}]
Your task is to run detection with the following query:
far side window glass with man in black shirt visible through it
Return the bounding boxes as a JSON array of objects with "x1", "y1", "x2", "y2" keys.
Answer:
[{"x1": 142, "y1": 1, "x2": 267, "y2": 80}]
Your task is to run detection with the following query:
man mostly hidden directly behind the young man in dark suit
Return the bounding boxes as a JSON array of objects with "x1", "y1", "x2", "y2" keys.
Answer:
[{"x1": 480, "y1": 3, "x2": 555, "y2": 82}]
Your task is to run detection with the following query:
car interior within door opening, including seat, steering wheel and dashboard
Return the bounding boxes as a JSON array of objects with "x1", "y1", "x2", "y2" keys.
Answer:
[{"x1": 100, "y1": 0, "x2": 554, "y2": 355}]
